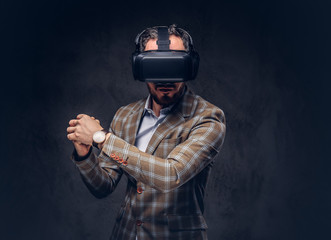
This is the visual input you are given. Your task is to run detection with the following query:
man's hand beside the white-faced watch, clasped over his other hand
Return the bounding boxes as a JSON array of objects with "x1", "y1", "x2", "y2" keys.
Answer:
[{"x1": 67, "y1": 114, "x2": 103, "y2": 145}]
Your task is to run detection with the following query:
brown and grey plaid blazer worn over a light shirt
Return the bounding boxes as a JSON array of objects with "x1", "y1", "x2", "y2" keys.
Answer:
[{"x1": 75, "y1": 87, "x2": 225, "y2": 240}]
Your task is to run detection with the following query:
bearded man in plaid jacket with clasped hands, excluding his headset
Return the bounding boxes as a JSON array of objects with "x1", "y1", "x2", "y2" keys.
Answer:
[{"x1": 67, "y1": 25, "x2": 225, "y2": 240}]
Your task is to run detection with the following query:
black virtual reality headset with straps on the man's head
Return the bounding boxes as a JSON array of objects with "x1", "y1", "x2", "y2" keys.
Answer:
[{"x1": 132, "y1": 26, "x2": 200, "y2": 83}]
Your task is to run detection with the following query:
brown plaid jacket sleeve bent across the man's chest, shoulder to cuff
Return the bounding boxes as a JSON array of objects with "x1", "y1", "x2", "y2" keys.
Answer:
[{"x1": 100, "y1": 108, "x2": 226, "y2": 192}]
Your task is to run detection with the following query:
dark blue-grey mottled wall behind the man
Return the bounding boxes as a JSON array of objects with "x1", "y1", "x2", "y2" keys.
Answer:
[{"x1": 0, "y1": 0, "x2": 331, "y2": 240}]
